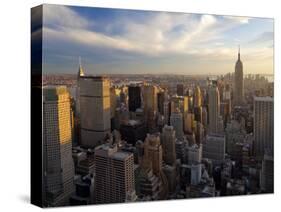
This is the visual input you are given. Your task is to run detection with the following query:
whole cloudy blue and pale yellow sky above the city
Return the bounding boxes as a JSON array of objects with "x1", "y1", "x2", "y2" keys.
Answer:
[{"x1": 39, "y1": 5, "x2": 274, "y2": 75}]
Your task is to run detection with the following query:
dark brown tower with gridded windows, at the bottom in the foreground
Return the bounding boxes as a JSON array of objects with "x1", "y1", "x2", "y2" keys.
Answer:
[{"x1": 95, "y1": 144, "x2": 136, "y2": 204}]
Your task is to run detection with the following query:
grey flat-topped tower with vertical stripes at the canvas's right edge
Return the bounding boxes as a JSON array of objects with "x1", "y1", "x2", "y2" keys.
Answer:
[{"x1": 254, "y1": 97, "x2": 274, "y2": 159}]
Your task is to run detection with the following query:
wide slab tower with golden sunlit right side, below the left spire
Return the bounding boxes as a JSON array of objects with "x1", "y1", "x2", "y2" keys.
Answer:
[{"x1": 80, "y1": 75, "x2": 111, "y2": 147}]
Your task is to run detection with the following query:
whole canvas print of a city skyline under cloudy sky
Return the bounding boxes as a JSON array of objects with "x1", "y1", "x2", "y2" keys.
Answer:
[{"x1": 31, "y1": 5, "x2": 274, "y2": 207}]
